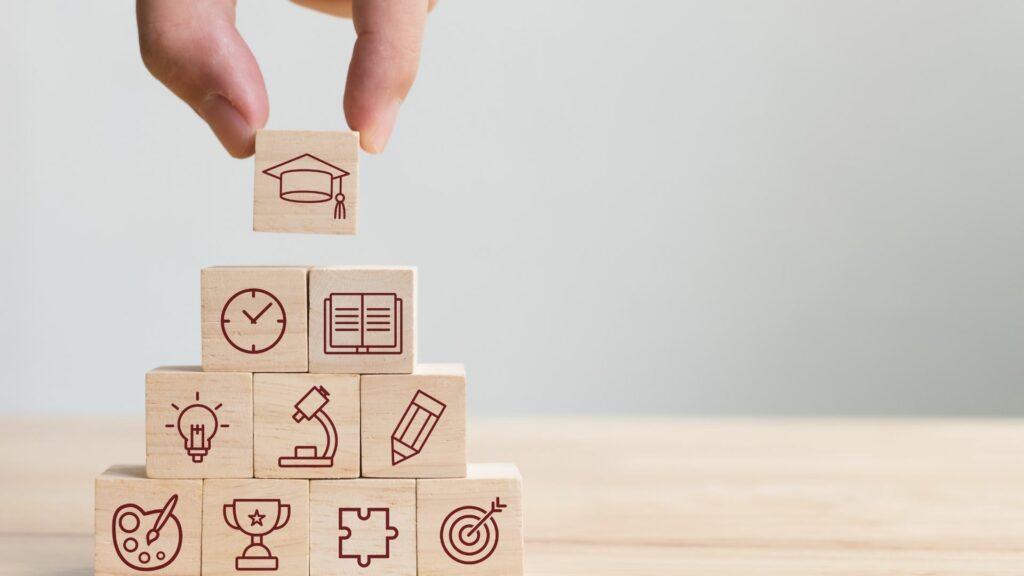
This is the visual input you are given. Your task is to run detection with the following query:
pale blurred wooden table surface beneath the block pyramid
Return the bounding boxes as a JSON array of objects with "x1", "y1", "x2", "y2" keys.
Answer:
[{"x1": 0, "y1": 418, "x2": 1024, "y2": 576}]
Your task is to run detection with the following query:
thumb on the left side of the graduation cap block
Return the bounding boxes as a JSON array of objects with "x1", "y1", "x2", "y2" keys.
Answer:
[{"x1": 136, "y1": 0, "x2": 269, "y2": 158}]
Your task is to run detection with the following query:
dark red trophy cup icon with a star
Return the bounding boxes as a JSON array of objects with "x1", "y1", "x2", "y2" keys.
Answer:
[{"x1": 224, "y1": 498, "x2": 292, "y2": 571}]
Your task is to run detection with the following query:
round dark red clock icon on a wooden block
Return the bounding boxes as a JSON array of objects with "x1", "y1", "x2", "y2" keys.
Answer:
[{"x1": 220, "y1": 288, "x2": 288, "y2": 354}]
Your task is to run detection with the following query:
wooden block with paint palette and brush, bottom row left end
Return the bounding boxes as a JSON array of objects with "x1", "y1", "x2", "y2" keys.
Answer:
[{"x1": 94, "y1": 465, "x2": 203, "y2": 576}]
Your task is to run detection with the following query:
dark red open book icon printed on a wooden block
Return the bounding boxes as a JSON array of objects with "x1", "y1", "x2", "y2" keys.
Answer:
[{"x1": 324, "y1": 292, "x2": 401, "y2": 354}]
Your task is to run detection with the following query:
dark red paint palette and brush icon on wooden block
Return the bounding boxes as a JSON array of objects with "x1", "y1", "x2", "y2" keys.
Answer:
[{"x1": 111, "y1": 494, "x2": 182, "y2": 572}]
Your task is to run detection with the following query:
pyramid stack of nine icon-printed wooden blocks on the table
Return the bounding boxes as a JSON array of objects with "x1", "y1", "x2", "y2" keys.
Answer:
[{"x1": 95, "y1": 133, "x2": 523, "y2": 576}]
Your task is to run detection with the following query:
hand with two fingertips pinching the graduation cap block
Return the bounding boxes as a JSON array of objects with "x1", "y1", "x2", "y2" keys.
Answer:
[{"x1": 136, "y1": 0, "x2": 436, "y2": 158}]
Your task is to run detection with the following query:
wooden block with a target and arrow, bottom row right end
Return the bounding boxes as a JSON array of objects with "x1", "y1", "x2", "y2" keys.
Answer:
[{"x1": 416, "y1": 464, "x2": 523, "y2": 576}]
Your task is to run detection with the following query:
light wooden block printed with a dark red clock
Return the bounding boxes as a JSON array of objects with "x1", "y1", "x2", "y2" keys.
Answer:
[{"x1": 202, "y1": 266, "x2": 308, "y2": 372}]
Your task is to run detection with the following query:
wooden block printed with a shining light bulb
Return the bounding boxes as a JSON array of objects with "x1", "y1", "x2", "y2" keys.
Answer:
[{"x1": 145, "y1": 366, "x2": 253, "y2": 478}]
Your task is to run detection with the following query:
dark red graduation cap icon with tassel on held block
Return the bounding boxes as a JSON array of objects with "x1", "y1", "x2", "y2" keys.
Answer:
[{"x1": 263, "y1": 154, "x2": 348, "y2": 220}]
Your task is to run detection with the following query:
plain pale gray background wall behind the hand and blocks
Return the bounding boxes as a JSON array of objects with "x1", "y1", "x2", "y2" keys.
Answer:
[{"x1": 0, "y1": 0, "x2": 1024, "y2": 415}]
